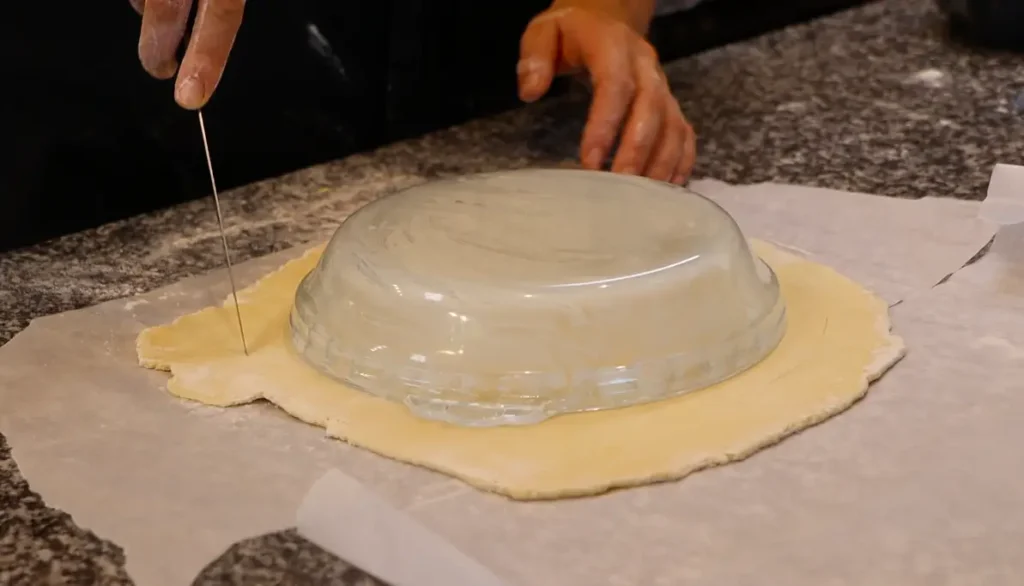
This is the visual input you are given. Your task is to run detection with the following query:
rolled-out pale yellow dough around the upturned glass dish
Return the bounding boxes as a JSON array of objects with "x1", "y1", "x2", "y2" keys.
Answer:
[{"x1": 138, "y1": 242, "x2": 904, "y2": 500}]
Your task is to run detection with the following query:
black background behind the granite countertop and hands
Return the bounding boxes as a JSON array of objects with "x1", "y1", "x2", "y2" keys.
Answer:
[{"x1": 0, "y1": 0, "x2": 880, "y2": 250}]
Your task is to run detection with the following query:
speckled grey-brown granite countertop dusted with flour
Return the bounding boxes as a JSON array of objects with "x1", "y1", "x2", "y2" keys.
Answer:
[{"x1": 0, "y1": 0, "x2": 1024, "y2": 585}]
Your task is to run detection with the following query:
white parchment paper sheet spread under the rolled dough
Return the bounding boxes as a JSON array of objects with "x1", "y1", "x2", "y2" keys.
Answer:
[{"x1": 0, "y1": 175, "x2": 1024, "y2": 586}]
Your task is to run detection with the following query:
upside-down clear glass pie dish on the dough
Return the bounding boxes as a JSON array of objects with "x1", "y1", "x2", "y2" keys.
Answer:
[{"x1": 291, "y1": 169, "x2": 785, "y2": 426}]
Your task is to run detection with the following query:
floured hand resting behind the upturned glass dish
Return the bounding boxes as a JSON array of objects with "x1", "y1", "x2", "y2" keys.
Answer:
[{"x1": 520, "y1": 0, "x2": 696, "y2": 183}]
